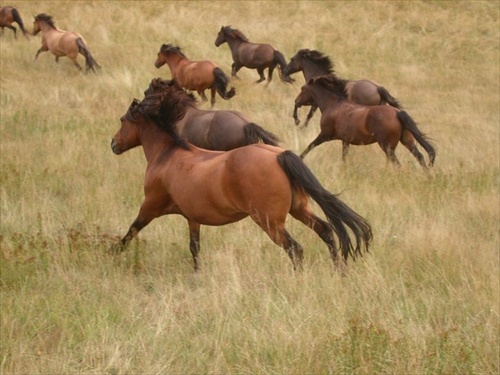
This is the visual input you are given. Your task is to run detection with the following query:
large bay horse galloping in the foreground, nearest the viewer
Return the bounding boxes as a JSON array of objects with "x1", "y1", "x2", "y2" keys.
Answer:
[{"x1": 111, "y1": 90, "x2": 372, "y2": 270}]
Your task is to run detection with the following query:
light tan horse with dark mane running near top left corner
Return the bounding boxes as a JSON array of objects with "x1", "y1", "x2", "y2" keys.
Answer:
[{"x1": 33, "y1": 13, "x2": 100, "y2": 72}]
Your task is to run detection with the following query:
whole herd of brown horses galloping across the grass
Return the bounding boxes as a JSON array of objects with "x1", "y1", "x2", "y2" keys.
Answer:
[{"x1": 0, "y1": 7, "x2": 436, "y2": 271}]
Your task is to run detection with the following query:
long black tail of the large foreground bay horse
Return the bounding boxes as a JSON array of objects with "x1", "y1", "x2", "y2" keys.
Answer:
[{"x1": 278, "y1": 151, "x2": 373, "y2": 260}]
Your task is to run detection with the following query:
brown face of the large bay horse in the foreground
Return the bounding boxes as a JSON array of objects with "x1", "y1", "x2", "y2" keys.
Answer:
[{"x1": 111, "y1": 99, "x2": 142, "y2": 155}]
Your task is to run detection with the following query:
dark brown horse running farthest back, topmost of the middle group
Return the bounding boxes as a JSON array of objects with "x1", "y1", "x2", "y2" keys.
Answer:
[{"x1": 215, "y1": 26, "x2": 295, "y2": 84}]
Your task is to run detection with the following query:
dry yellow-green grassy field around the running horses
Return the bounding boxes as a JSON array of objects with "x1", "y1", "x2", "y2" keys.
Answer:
[{"x1": 0, "y1": 1, "x2": 500, "y2": 374}]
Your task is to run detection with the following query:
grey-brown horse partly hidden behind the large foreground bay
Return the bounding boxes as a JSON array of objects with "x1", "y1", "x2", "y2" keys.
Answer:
[{"x1": 144, "y1": 78, "x2": 279, "y2": 151}]
